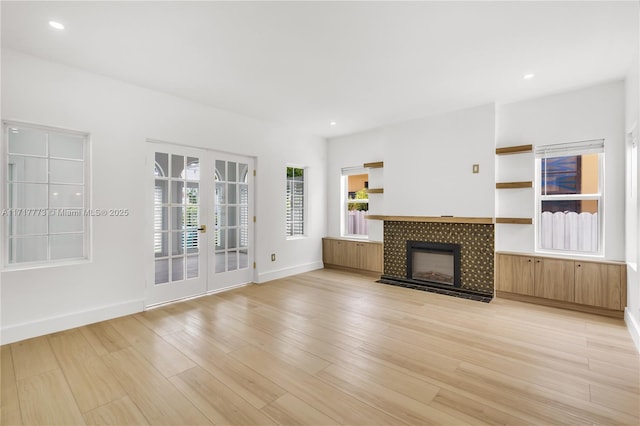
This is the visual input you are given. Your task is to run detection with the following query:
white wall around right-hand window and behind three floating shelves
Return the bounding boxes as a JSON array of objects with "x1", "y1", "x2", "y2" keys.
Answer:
[{"x1": 496, "y1": 81, "x2": 625, "y2": 260}]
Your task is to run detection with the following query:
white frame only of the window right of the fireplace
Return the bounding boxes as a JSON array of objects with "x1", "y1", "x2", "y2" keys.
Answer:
[{"x1": 534, "y1": 139, "x2": 605, "y2": 257}]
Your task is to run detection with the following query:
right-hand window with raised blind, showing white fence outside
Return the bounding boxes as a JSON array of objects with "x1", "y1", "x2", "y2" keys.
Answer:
[{"x1": 536, "y1": 140, "x2": 604, "y2": 254}]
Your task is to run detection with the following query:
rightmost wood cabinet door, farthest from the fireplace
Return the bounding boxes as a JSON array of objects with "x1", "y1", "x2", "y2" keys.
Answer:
[{"x1": 575, "y1": 262, "x2": 622, "y2": 310}]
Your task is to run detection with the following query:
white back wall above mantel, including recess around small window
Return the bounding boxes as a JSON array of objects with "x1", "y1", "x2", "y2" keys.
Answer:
[{"x1": 327, "y1": 104, "x2": 495, "y2": 241}]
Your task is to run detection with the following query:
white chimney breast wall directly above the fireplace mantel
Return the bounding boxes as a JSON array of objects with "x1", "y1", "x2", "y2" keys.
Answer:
[{"x1": 384, "y1": 104, "x2": 495, "y2": 218}]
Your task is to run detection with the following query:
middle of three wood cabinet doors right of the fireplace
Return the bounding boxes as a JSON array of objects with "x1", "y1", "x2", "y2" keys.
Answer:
[{"x1": 534, "y1": 258, "x2": 575, "y2": 302}]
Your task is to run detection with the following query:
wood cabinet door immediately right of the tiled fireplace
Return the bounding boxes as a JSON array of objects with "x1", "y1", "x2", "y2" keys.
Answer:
[{"x1": 496, "y1": 253, "x2": 534, "y2": 296}]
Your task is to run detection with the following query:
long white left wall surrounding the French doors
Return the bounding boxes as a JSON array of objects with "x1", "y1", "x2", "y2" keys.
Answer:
[{"x1": 1, "y1": 50, "x2": 326, "y2": 343}]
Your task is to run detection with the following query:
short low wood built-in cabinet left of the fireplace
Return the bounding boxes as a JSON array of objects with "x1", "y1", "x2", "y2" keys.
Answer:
[{"x1": 322, "y1": 237, "x2": 383, "y2": 275}]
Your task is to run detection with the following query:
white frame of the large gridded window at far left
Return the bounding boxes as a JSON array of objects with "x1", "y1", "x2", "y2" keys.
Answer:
[{"x1": 0, "y1": 120, "x2": 92, "y2": 270}]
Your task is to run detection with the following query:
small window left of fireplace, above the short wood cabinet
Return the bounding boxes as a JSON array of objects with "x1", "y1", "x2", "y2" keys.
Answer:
[{"x1": 343, "y1": 172, "x2": 369, "y2": 236}]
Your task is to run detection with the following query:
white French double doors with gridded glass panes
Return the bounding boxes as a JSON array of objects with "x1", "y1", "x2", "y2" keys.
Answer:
[{"x1": 145, "y1": 142, "x2": 253, "y2": 306}]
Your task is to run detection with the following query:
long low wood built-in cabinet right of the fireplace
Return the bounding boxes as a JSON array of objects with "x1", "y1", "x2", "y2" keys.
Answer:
[{"x1": 495, "y1": 253, "x2": 627, "y2": 317}]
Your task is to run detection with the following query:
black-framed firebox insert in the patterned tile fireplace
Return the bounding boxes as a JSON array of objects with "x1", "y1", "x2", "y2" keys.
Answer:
[{"x1": 406, "y1": 241, "x2": 461, "y2": 288}]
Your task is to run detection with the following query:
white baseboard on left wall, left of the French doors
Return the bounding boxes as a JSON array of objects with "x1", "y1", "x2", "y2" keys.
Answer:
[{"x1": 0, "y1": 299, "x2": 144, "y2": 345}]
